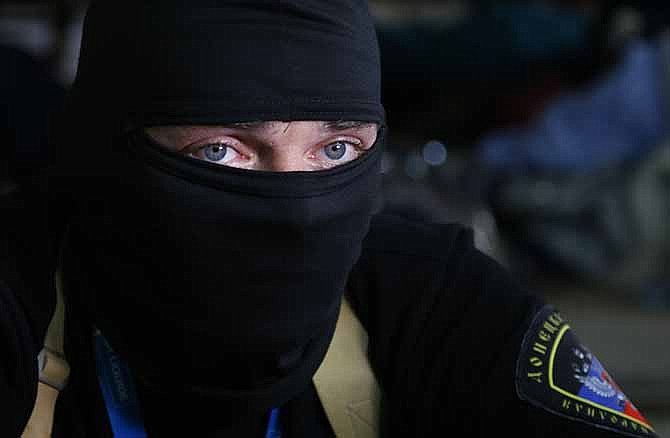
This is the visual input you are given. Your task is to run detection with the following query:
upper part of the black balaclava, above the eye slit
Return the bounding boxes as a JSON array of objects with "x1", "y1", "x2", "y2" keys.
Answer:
[{"x1": 72, "y1": 0, "x2": 384, "y2": 128}]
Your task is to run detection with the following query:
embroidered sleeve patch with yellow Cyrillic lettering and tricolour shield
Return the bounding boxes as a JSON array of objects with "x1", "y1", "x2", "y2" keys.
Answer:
[{"x1": 516, "y1": 306, "x2": 657, "y2": 437}]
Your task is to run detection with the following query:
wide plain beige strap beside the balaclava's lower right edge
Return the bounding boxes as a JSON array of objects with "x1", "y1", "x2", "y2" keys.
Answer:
[{"x1": 314, "y1": 299, "x2": 381, "y2": 438}]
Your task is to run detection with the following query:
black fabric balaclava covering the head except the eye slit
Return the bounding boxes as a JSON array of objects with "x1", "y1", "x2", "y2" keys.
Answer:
[{"x1": 63, "y1": 0, "x2": 384, "y2": 410}]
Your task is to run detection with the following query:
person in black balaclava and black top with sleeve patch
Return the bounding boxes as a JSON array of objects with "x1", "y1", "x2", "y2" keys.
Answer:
[{"x1": 0, "y1": 0, "x2": 654, "y2": 438}]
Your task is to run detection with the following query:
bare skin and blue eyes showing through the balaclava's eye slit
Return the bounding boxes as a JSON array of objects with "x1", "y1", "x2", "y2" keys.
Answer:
[{"x1": 146, "y1": 121, "x2": 378, "y2": 172}]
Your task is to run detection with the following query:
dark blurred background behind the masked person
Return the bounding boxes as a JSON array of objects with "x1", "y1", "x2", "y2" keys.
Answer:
[{"x1": 0, "y1": 0, "x2": 670, "y2": 436}]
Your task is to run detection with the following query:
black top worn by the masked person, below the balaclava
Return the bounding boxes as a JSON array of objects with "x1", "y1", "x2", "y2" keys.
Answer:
[{"x1": 0, "y1": 204, "x2": 653, "y2": 438}]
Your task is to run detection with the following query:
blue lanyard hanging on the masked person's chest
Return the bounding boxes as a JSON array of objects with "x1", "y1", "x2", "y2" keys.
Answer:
[{"x1": 93, "y1": 330, "x2": 282, "y2": 438}]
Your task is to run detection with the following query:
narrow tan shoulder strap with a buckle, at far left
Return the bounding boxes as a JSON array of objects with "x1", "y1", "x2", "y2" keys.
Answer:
[{"x1": 21, "y1": 273, "x2": 70, "y2": 438}]
